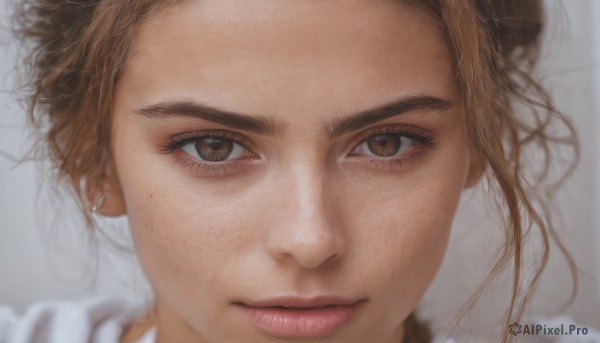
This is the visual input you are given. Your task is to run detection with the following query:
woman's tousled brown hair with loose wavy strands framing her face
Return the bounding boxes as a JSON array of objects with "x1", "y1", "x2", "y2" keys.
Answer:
[{"x1": 16, "y1": 0, "x2": 579, "y2": 342}]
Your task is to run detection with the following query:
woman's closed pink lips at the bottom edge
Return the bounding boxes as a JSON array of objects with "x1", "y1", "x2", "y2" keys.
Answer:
[{"x1": 235, "y1": 297, "x2": 365, "y2": 338}]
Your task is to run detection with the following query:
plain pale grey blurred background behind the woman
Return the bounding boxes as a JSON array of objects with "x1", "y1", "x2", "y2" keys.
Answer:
[{"x1": 0, "y1": 0, "x2": 600, "y2": 340}]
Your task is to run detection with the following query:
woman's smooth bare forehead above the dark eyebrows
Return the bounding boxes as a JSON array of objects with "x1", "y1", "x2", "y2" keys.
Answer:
[{"x1": 118, "y1": 0, "x2": 455, "y2": 115}]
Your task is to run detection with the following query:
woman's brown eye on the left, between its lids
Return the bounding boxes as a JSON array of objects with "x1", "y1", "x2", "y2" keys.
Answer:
[{"x1": 181, "y1": 136, "x2": 246, "y2": 162}]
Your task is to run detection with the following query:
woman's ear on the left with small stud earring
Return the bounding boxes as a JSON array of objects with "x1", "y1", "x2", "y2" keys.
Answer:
[{"x1": 86, "y1": 158, "x2": 127, "y2": 217}]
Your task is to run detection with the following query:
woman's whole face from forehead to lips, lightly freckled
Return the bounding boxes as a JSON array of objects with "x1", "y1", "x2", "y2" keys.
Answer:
[{"x1": 112, "y1": 0, "x2": 469, "y2": 342}]
